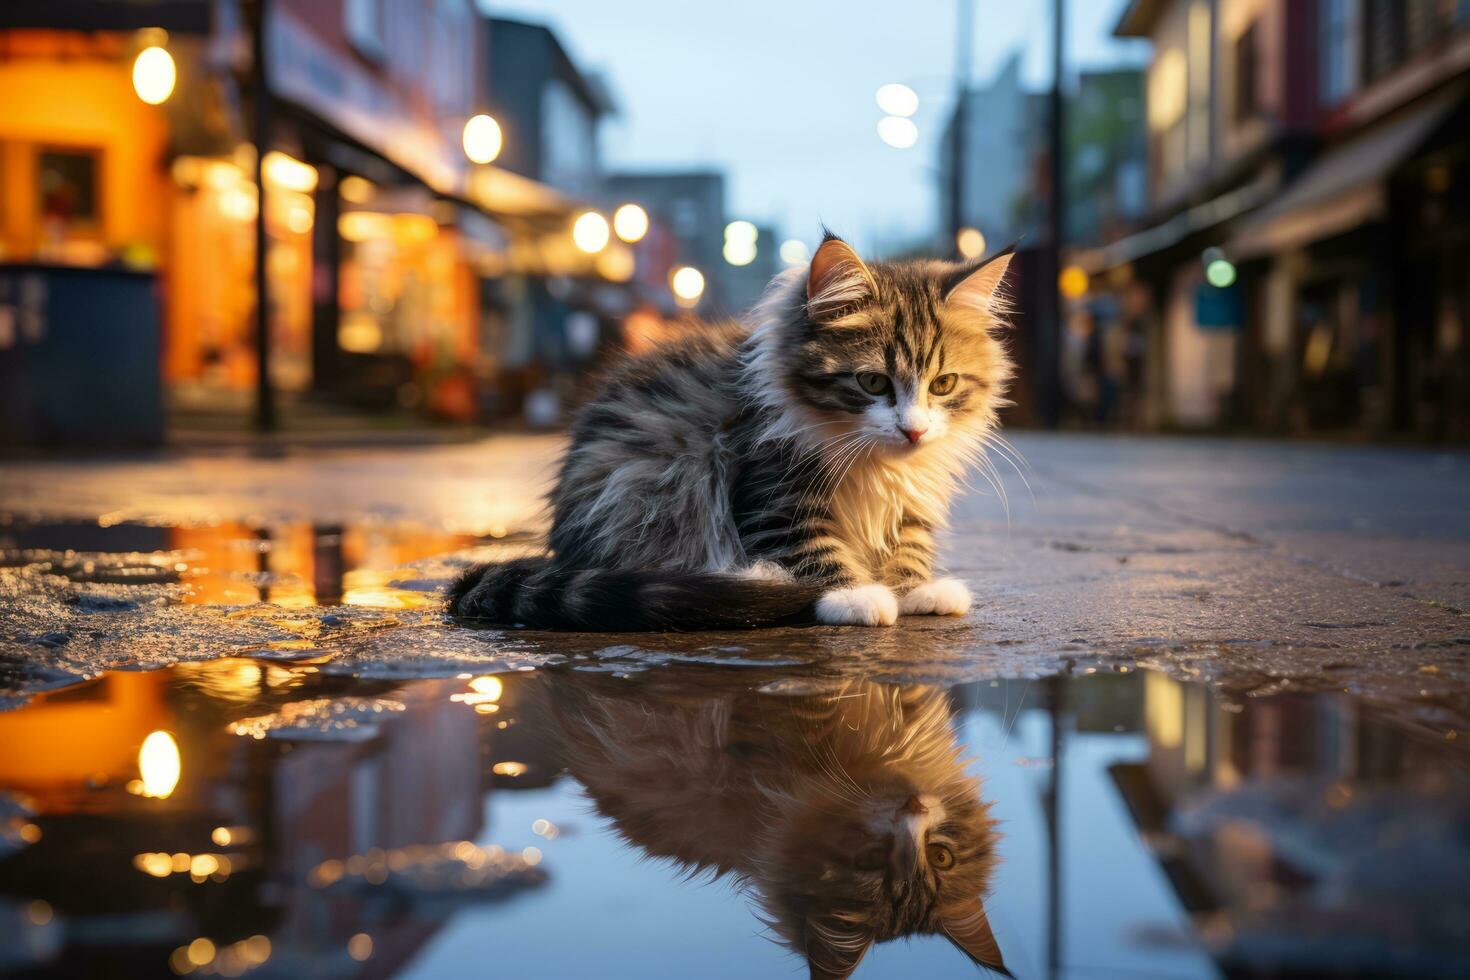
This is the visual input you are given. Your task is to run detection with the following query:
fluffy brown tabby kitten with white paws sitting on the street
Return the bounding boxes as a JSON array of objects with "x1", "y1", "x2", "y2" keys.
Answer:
[{"x1": 450, "y1": 234, "x2": 1011, "y2": 630}]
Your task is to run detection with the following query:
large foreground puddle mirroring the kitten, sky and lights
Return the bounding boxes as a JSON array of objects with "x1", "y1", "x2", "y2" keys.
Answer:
[{"x1": 0, "y1": 657, "x2": 1470, "y2": 980}]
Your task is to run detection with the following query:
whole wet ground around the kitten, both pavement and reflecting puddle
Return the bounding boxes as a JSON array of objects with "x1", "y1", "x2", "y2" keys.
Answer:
[{"x1": 0, "y1": 436, "x2": 1470, "y2": 977}]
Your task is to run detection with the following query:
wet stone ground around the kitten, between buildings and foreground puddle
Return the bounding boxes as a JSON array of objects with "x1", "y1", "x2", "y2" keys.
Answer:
[{"x1": 0, "y1": 433, "x2": 1470, "y2": 738}]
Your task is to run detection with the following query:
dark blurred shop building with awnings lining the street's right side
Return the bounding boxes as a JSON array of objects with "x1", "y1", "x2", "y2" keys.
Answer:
[{"x1": 1085, "y1": 0, "x2": 1470, "y2": 438}]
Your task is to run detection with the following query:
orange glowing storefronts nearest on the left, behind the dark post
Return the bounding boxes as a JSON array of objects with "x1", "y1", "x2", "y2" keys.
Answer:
[{"x1": 0, "y1": 0, "x2": 506, "y2": 420}]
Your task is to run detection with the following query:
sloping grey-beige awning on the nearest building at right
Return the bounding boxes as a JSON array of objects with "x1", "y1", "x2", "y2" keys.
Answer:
[{"x1": 1227, "y1": 97, "x2": 1454, "y2": 259}]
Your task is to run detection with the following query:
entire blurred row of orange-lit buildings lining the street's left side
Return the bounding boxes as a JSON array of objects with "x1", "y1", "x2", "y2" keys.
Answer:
[{"x1": 0, "y1": 0, "x2": 667, "y2": 442}]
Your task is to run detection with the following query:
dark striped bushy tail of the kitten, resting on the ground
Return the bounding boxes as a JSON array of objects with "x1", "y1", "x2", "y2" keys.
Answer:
[{"x1": 448, "y1": 557, "x2": 823, "y2": 632}]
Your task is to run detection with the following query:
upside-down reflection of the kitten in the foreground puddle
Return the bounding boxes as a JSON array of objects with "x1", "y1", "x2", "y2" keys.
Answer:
[{"x1": 550, "y1": 674, "x2": 1010, "y2": 979}]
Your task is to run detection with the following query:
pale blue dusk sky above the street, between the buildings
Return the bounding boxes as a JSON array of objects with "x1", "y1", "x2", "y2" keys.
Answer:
[{"x1": 481, "y1": 0, "x2": 1147, "y2": 258}]
